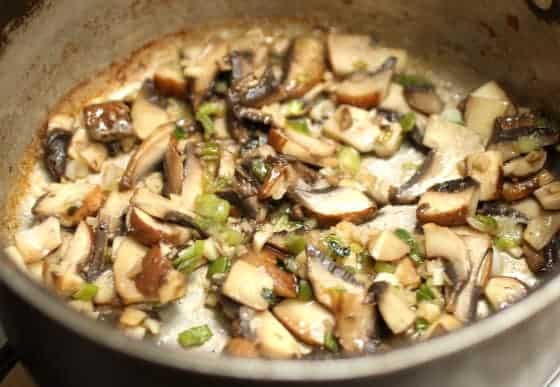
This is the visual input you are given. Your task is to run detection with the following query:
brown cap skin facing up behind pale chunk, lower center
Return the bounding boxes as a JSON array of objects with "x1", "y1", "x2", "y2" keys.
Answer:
[{"x1": 240, "y1": 247, "x2": 297, "y2": 298}]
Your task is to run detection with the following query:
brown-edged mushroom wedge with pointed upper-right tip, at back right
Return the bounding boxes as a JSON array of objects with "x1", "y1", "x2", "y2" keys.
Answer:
[{"x1": 335, "y1": 58, "x2": 397, "y2": 109}]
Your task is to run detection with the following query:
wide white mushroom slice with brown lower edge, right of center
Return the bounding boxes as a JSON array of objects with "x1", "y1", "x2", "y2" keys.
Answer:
[{"x1": 293, "y1": 187, "x2": 377, "y2": 226}]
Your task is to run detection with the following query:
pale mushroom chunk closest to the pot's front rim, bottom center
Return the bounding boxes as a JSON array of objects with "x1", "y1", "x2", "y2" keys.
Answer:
[{"x1": 251, "y1": 311, "x2": 311, "y2": 359}]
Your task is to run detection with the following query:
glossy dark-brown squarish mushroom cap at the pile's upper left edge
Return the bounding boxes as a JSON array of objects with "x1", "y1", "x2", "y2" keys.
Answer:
[{"x1": 84, "y1": 101, "x2": 134, "y2": 143}]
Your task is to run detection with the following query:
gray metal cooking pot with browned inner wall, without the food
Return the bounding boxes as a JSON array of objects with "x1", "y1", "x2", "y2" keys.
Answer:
[{"x1": 0, "y1": 0, "x2": 560, "y2": 387}]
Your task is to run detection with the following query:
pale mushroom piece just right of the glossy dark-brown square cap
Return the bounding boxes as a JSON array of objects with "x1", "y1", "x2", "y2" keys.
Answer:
[{"x1": 130, "y1": 82, "x2": 171, "y2": 140}]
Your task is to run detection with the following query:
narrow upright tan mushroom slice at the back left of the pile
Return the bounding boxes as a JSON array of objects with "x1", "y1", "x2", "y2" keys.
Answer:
[{"x1": 191, "y1": 38, "x2": 229, "y2": 109}]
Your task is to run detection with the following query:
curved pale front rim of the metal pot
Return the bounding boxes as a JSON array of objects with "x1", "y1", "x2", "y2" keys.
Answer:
[{"x1": 0, "y1": 252, "x2": 560, "y2": 381}]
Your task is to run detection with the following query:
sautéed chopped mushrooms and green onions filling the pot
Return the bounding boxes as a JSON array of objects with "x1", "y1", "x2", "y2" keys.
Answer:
[{"x1": 7, "y1": 27, "x2": 560, "y2": 359}]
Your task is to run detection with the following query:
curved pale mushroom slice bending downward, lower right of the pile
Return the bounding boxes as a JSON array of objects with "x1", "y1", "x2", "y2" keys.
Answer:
[{"x1": 422, "y1": 223, "x2": 472, "y2": 284}]
